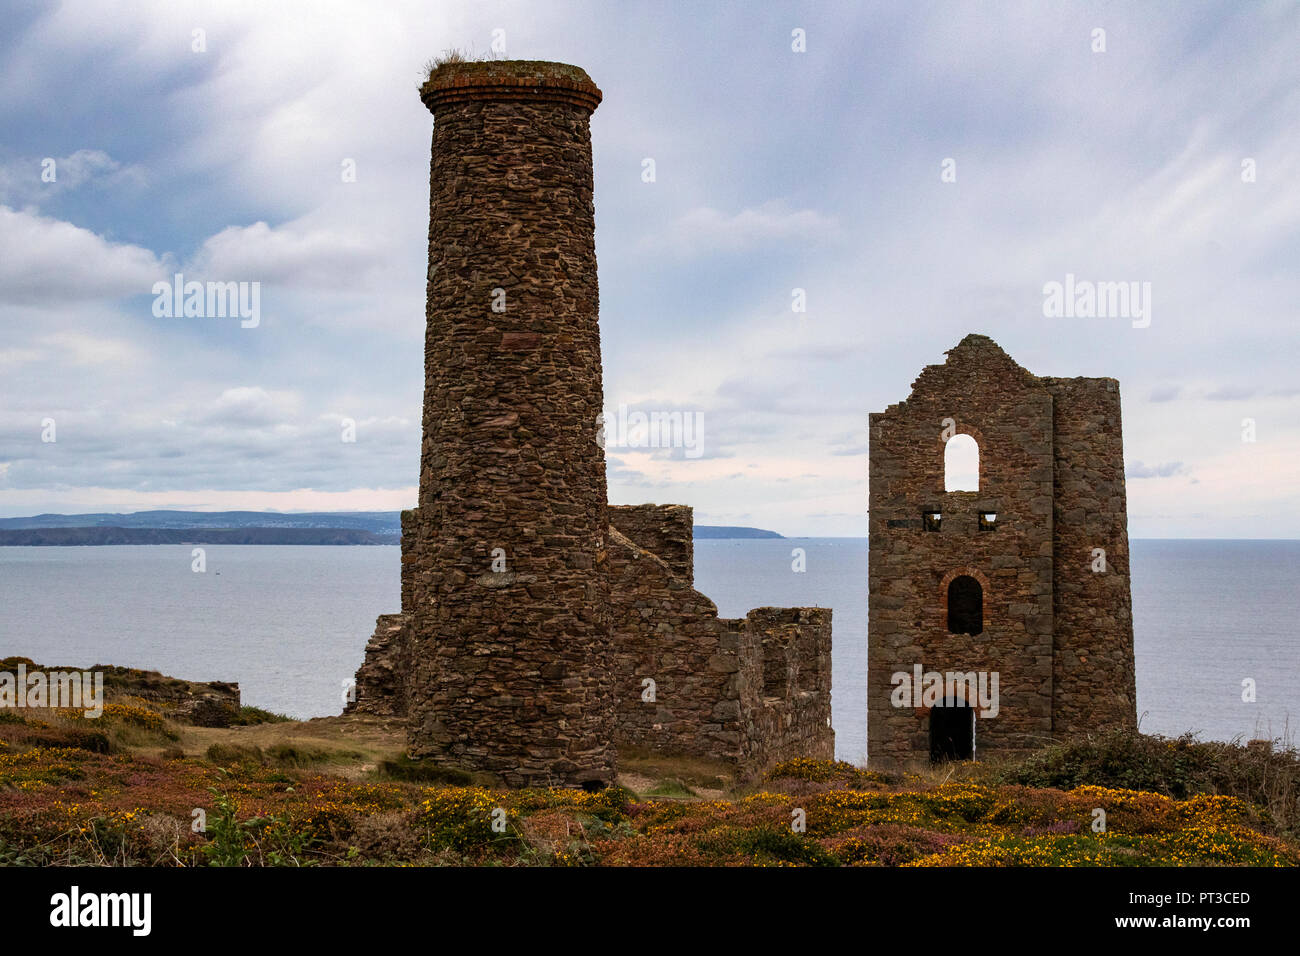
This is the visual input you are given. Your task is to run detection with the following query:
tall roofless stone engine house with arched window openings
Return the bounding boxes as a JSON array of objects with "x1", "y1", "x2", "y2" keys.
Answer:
[{"x1": 867, "y1": 336, "x2": 1135, "y2": 765}]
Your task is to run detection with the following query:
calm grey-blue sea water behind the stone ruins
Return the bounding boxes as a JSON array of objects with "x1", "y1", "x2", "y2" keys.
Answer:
[{"x1": 0, "y1": 538, "x2": 1300, "y2": 761}]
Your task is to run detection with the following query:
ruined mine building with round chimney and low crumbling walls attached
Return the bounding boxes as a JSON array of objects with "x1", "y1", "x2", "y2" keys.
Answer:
[{"x1": 348, "y1": 61, "x2": 833, "y2": 788}]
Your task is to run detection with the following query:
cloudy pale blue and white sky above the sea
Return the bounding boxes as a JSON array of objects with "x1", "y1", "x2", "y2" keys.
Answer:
[{"x1": 0, "y1": 0, "x2": 1300, "y2": 537}]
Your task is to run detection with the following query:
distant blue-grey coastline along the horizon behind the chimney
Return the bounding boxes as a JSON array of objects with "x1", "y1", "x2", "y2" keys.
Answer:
[{"x1": 0, "y1": 511, "x2": 784, "y2": 548}]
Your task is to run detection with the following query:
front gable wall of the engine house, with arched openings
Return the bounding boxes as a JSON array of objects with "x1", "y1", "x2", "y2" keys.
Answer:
[{"x1": 867, "y1": 337, "x2": 1053, "y2": 763}]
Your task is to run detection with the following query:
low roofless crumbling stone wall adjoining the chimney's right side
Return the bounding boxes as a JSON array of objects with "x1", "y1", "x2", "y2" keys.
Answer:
[{"x1": 610, "y1": 515, "x2": 835, "y2": 770}]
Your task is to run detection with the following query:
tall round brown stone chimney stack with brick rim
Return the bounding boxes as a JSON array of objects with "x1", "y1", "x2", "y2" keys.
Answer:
[{"x1": 403, "y1": 60, "x2": 615, "y2": 787}]
